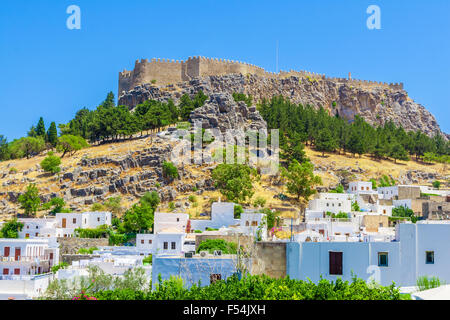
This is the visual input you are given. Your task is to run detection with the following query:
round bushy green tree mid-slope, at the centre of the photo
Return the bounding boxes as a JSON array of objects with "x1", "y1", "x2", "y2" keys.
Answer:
[{"x1": 211, "y1": 163, "x2": 255, "y2": 201}]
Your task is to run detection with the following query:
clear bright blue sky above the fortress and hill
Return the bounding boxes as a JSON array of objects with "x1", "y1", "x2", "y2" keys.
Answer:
[{"x1": 0, "y1": 0, "x2": 450, "y2": 141}]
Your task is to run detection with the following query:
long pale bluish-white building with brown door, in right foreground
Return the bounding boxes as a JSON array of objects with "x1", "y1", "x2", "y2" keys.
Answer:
[{"x1": 286, "y1": 221, "x2": 450, "y2": 286}]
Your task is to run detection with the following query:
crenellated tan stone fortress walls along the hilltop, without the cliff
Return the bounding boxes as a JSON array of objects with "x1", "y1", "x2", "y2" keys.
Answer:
[{"x1": 119, "y1": 57, "x2": 403, "y2": 97}]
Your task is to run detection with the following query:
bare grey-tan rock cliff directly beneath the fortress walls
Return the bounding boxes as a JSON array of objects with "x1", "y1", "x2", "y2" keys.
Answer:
[{"x1": 119, "y1": 74, "x2": 449, "y2": 139}]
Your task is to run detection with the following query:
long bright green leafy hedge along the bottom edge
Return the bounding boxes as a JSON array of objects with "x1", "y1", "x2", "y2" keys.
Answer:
[{"x1": 89, "y1": 275, "x2": 407, "y2": 300}]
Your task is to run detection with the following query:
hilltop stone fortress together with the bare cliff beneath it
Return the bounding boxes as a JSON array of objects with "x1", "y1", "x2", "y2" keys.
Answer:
[{"x1": 118, "y1": 57, "x2": 449, "y2": 138}]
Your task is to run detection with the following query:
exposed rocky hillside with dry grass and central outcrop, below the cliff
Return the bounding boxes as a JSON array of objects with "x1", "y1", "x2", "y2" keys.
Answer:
[{"x1": 0, "y1": 89, "x2": 450, "y2": 219}]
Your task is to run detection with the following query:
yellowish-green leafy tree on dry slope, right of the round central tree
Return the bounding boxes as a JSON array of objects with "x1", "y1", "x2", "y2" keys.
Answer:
[{"x1": 282, "y1": 159, "x2": 322, "y2": 201}]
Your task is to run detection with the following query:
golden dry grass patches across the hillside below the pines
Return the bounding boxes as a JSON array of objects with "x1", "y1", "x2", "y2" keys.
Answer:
[{"x1": 0, "y1": 134, "x2": 448, "y2": 219}]
